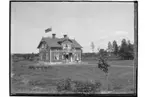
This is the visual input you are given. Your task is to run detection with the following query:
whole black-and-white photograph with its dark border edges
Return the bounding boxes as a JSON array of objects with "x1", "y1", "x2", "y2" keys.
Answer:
[{"x1": 9, "y1": 1, "x2": 138, "y2": 95}]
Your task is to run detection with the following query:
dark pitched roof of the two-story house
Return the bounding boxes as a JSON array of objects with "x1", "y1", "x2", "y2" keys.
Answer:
[{"x1": 37, "y1": 37, "x2": 82, "y2": 48}]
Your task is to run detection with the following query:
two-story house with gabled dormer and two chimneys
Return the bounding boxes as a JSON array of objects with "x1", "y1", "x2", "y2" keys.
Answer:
[{"x1": 37, "y1": 34, "x2": 82, "y2": 63}]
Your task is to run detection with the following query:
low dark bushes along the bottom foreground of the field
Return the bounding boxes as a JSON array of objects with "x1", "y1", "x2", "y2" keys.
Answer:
[{"x1": 57, "y1": 78, "x2": 101, "y2": 93}]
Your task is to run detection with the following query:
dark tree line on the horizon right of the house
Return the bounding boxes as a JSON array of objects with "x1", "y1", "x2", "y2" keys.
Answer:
[{"x1": 82, "y1": 39, "x2": 134, "y2": 60}]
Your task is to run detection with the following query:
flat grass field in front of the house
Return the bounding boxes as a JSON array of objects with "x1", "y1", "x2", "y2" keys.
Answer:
[{"x1": 11, "y1": 60, "x2": 136, "y2": 93}]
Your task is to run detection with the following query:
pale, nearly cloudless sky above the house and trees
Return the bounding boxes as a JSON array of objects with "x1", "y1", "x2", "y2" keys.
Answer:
[{"x1": 11, "y1": 2, "x2": 134, "y2": 53}]
